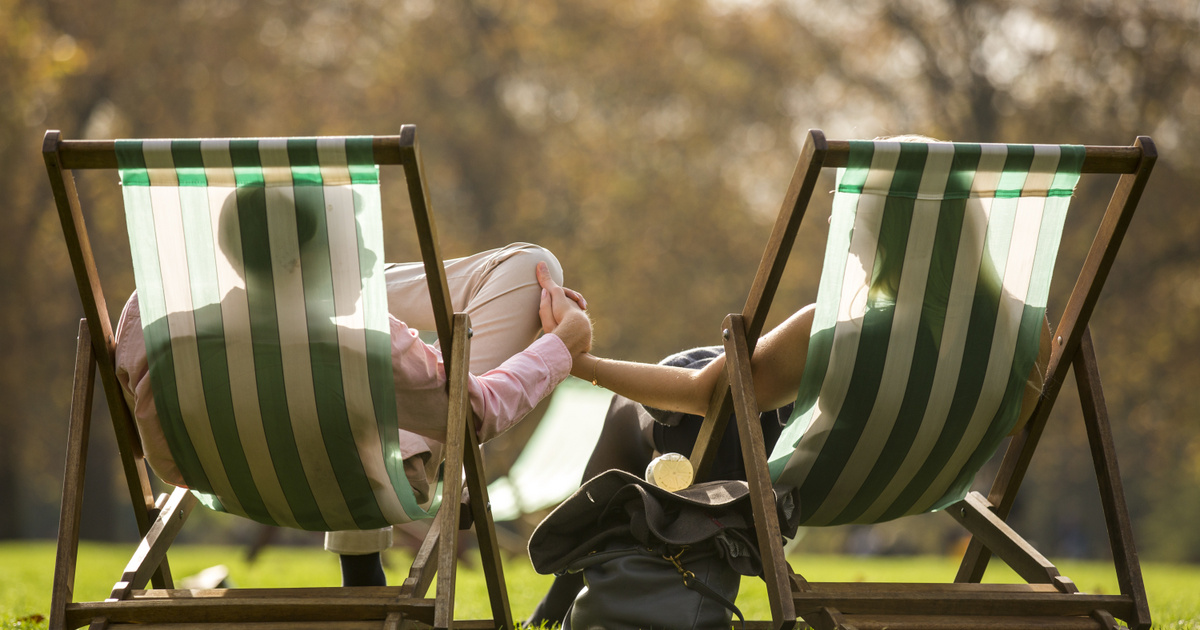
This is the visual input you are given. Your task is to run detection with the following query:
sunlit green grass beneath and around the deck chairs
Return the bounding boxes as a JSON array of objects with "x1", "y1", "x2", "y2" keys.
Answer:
[{"x1": 0, "y1": 541, "x2": 1200, "y2": 630}]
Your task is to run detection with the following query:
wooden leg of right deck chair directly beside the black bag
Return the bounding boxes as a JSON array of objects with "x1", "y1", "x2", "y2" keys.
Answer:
[{"x1": 725, "y1": 314, "x2": 796, "y2": 628}]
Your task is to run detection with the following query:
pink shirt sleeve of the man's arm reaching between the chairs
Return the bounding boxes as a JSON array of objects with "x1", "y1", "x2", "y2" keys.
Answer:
[{"x1": 391, "y1": 318, "x2": 571, "y2": 442}]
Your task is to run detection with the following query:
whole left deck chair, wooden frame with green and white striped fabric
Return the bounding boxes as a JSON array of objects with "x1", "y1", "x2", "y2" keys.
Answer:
[{"x1": 43, "y1": 126, "x2": 512, "y2": 629}]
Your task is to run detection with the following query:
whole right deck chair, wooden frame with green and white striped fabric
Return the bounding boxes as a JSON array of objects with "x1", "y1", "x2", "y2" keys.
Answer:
[{"x1": 692, "y1": 131, "x2": 1156, "y2": 630}]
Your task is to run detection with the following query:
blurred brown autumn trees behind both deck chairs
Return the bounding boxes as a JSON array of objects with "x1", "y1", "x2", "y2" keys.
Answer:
[{"x1": 0, "y1": 0, "x2": 1200, "y2": 562}]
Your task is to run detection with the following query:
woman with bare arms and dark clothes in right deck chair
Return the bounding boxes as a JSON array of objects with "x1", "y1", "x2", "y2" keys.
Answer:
[{"x1": 528, "y1": 166, "x2": 1050, "y2": 625}]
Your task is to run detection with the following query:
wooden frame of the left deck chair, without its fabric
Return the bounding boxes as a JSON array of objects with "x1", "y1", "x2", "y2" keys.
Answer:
[{"x1": 42, "y1": 125, "x2": 512, "y2": 629}]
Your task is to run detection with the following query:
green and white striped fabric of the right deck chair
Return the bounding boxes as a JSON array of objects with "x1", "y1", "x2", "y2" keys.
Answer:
[{"x1": 769, "y1": 142, "x2": 1084, "y2": 526}]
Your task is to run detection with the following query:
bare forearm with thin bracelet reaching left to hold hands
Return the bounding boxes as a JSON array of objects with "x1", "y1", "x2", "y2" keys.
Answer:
[{"x1": 571, "y1": 354, "x2": 725, "y2": 415}]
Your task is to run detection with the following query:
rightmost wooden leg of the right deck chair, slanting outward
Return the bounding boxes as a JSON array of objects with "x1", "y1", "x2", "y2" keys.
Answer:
[{"x1": 1074, "y1": 330, "x2": 1151, "y2": 629}]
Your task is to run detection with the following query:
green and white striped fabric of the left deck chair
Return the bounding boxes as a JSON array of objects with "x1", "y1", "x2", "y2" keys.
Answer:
[{"x1": 116, "y1": 138, "x2": 428, "y2": 530}]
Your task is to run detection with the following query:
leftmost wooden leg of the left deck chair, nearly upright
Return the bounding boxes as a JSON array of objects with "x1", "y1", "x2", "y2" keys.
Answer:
[{"x1": 49, "y1": 319, "x2": 96, "y2": 630}]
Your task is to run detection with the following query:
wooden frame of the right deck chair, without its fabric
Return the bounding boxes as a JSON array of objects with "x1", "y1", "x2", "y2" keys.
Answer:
[{"x1": 691, "y1": 130, "x2": 1157, "y2": 630}]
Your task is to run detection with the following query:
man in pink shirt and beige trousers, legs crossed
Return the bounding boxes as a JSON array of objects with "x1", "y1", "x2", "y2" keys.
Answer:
[{"x1": 115, "y1": 228, "x2": 592, "y2": 586}]
